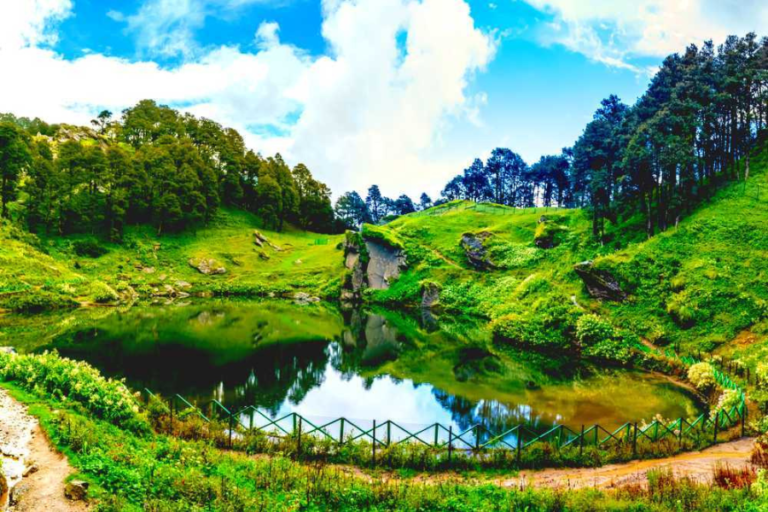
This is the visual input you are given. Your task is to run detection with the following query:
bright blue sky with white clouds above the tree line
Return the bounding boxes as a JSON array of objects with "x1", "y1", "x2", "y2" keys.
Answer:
[{"x1": 0, "y1": 0, "x2": 768, "y2": 196}]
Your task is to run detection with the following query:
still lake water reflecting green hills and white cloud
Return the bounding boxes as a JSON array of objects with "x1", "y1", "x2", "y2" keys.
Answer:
[{"x1": 0, "y1": 300, "x2": 698, "y2": 436}]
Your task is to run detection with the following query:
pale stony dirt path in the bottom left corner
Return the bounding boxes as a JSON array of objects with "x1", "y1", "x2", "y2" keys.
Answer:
[{"x1": 0, "y1": 389, "x2": 88, "y2": 512}]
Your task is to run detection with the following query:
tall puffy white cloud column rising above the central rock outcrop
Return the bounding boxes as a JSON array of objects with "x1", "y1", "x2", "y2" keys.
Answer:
[{"x1": 291, "y1": 0, "x2": 495, "y2": 195}]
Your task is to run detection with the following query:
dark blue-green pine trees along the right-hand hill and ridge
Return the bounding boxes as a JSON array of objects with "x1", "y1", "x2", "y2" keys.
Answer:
[{"x1": 344, "y1": 33, "x2": 768, "y2": 239}]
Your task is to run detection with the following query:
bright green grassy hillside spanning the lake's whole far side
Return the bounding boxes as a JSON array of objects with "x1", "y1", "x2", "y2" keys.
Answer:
[{"x1": 0, "y1": 145, "x2": 768, "y2": 364}]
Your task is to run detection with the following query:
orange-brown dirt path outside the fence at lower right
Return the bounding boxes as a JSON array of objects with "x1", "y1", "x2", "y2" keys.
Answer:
[{"x1": 497, "y1": 438, "x2": 754, "y2": 489}]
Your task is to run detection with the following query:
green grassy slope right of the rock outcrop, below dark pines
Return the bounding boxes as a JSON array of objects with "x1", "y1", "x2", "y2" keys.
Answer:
[{"x1": 364, "y1": 145, "x2": 768, "y2": 360}]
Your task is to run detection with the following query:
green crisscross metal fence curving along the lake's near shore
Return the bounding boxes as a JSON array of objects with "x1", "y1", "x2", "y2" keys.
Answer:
[{"x1": 145, "y1": 346, "x2": 748, "y2": 460}]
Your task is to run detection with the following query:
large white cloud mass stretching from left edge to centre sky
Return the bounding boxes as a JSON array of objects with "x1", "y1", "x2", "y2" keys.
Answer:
[{"x1": 0, "y1": 0, "x2": 495, "y2": 195}]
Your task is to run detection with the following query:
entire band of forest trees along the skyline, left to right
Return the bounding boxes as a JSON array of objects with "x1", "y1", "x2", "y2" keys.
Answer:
[{"x1": 0, "y1": 33, "x2": 768, "y2": 241}]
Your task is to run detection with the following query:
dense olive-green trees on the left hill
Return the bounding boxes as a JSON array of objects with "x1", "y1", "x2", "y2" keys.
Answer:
[{"x1": 0, "y1": 101, "x2": 336, "y2": 241}]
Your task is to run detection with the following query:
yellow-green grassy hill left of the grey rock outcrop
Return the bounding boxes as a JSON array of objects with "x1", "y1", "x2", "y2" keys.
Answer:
[{"x1": 0, "y1": 210, "x2": 343, "y2": 308}]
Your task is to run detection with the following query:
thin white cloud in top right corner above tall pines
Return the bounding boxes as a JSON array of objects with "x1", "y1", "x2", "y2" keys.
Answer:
[{"x1": 525, "y1": 0, "x2": 768, "y2": 71}]
